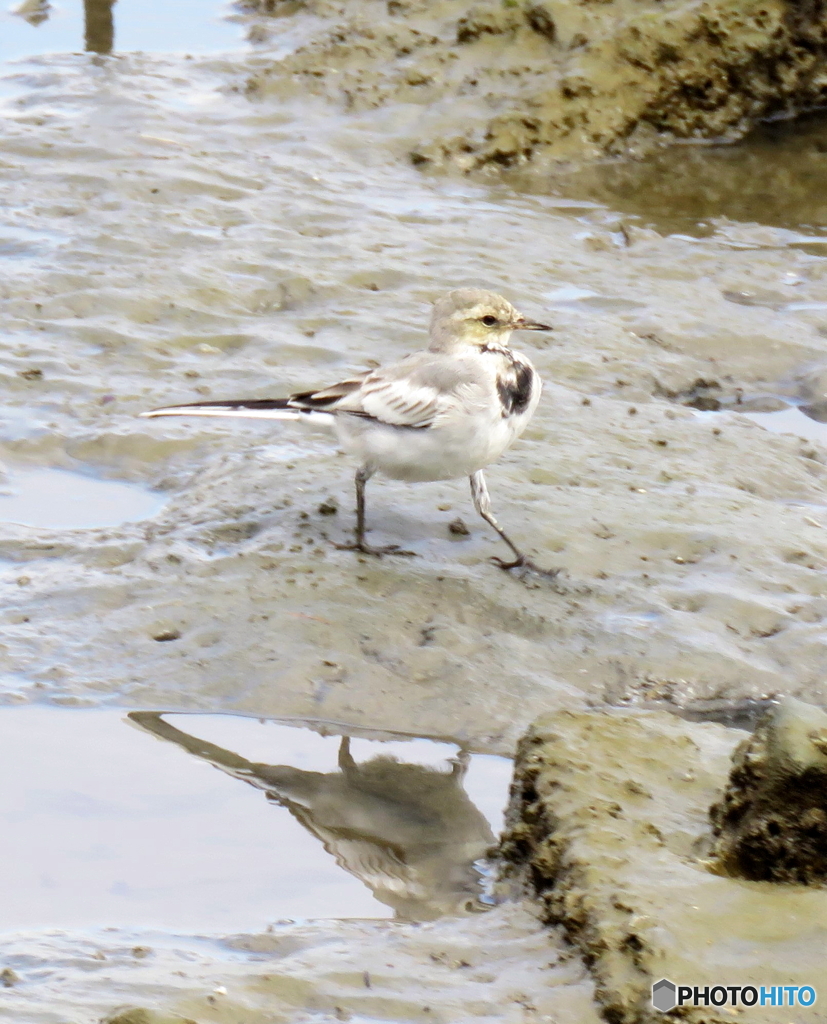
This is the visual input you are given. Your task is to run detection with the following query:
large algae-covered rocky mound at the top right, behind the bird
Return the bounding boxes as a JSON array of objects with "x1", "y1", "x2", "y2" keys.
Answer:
[{"x1": 248, "y1": 0, "x2": 827, "y2": 171}]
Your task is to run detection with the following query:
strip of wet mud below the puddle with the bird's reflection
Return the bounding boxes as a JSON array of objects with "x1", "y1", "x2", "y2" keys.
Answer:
[{"x1": 0, "y1": 903, "x2": 600, "y2": 1024}]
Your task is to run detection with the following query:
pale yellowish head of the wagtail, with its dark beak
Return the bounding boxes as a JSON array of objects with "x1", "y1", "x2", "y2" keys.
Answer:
[{"x1": 431, "y1": 288, "x2": 552, "y2": 351}]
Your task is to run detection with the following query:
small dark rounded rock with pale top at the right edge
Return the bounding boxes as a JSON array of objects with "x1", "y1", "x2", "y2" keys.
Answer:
[{"x1": 710, "y1": 697, "x2": 827, "y2": 885}]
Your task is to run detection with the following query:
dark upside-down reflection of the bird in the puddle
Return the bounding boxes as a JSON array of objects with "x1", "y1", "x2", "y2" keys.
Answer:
[{"x1": 129, "y1": 712, "x2": 494, "y2": 921}]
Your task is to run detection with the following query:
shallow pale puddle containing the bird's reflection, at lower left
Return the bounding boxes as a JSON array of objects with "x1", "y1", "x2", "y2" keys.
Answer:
[{"x1": 0, "y1": 707, "x2": 511, "y2": 934}]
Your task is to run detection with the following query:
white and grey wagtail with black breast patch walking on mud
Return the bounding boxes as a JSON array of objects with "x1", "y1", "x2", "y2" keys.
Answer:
[{"x1": 141, "y1": 288, "x2": 553, "y2": 574}]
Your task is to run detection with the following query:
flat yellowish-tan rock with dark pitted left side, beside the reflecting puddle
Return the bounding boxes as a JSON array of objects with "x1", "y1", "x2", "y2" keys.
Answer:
[{"x1": 502, "y1": 711, "x2": 827, "y2": 1024}]
